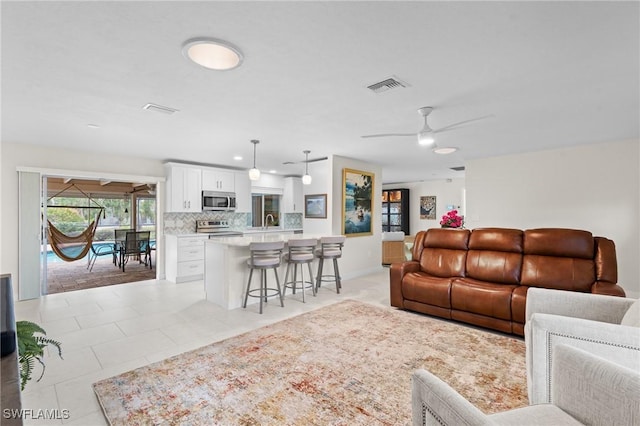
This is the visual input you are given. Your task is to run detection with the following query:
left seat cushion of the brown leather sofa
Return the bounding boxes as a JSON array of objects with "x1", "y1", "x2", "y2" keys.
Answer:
[{"x1": 402, "y1": 272, "x2": 451, "y2": 309}]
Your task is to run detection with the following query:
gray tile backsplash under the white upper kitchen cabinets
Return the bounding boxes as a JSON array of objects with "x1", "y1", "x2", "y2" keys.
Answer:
[{"x1": 164, "y1": 212, "x2": 302, "y2": 235}]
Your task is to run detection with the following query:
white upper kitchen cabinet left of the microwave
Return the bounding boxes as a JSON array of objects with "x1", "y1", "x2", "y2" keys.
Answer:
[{"x1": 166, "y1": 163, "x2": 202, "y2": 212}]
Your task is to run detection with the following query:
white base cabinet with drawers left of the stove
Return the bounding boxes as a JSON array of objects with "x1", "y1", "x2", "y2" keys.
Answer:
[{"x1": 165, "y1": 234, "x2": 208, "y2": 283}]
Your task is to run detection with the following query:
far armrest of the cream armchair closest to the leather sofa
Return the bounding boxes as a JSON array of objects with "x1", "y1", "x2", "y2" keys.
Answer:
[{"x1": 525, "y1": 287, "x2": 635, "y2": 324}]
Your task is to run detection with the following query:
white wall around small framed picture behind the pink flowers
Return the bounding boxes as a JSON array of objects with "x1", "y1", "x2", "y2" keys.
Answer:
[{"x1": 382, "y1": 178, "x2": 466, "y2": 235}]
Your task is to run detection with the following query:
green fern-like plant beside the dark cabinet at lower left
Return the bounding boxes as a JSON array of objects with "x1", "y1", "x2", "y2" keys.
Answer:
[{"x1": 16, "y1": 321, "x2": 62, "y2": 390}]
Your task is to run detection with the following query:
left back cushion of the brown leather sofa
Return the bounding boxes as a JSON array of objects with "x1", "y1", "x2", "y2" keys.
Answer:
[{"x1": 420, "y1": 228, "x2": 470, "y2": 278}]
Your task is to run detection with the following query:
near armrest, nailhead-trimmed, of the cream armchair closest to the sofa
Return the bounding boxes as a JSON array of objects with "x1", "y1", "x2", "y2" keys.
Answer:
[{"x1": 524, "y1": 313, "x2": 640, "y2": 404}]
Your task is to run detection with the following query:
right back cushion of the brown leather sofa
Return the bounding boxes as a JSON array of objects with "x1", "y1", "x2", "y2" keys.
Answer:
[{"x1": 520, "y1": 228, "x2": 596, "y2": 292}]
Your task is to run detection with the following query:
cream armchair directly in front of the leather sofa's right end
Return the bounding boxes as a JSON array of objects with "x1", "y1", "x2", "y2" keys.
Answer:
[{"x1": 524, "y1": 288, "x2": 640, "y2": 404}]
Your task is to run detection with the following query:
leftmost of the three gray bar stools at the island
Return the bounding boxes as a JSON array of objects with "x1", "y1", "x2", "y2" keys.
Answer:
[{"x1": 242, "y1": 241, "x2": 284, "y2": 313}]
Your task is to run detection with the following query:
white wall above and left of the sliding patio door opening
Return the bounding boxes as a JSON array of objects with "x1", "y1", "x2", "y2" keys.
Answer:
[{"x1": 0, "y1": 143, "x2": 164, "y2": 298}]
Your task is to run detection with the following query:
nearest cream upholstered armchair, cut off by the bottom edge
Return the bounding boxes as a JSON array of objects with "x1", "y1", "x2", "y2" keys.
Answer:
[{"x1": 412, "y1": 345, "x2": 640, "y2": 426}]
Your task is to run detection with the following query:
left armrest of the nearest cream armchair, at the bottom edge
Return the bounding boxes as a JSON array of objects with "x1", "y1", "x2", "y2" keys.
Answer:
[{"x1": 411, "y1": 370, "x2": 493, "y2": 426}]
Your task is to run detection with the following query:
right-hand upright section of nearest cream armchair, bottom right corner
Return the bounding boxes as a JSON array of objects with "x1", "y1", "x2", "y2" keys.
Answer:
[{"x1": 551, "y1": 345, "x2": 640, "y2": 425}]
